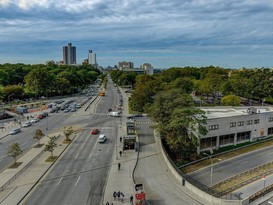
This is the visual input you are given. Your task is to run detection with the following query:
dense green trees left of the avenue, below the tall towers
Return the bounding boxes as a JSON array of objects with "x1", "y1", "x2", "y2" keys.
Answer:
[{"x1": 0, "y1": 63, "x2": 101, "y2": 101}]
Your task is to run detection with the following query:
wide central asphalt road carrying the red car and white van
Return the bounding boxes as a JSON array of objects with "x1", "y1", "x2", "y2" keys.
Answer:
[{"x1": 25, "y1": 78, "x2": 119, "y2": 205}]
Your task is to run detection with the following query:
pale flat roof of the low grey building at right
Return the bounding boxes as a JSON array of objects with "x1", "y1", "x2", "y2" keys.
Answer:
[{"x1": 200, "y1": 106, "x2": 273, "y2": 119}]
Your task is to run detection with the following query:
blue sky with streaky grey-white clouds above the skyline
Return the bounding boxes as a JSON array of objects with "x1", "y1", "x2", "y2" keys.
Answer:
[{"x1": 0, "y1": 0, "x2": 273, "y2": 68}]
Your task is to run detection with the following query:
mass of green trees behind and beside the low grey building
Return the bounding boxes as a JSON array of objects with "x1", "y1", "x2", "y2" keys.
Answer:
[{"x1": 111, "y1": 66, "x2": 273, "y2": 162}]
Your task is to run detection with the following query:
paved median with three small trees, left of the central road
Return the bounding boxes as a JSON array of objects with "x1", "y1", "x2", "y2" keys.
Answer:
[{"x1": 0, "y1": 133, "x2": 66, "y2": 205}]
